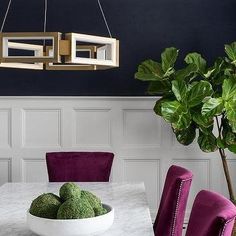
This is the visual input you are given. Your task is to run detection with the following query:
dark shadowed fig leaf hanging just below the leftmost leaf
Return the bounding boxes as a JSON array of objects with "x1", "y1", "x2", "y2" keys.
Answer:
[{"x1": 147, "y1": 80, "x2": 171, "y2": 95}]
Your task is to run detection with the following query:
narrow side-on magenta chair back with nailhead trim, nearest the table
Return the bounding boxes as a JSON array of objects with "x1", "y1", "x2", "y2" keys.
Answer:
[{"x1": 153, "y1": 165, "x2": 193, "y2": 236}]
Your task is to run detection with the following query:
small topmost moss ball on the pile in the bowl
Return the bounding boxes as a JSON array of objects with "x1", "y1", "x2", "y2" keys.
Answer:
[{"x1": 59, "y1": 183, "x2": 81, "y2": 201}]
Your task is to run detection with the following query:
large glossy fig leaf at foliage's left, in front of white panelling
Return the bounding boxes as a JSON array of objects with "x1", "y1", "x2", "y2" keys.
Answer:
[{"x1": 161, "y1": 101, "x2": 191, "y2": 130}]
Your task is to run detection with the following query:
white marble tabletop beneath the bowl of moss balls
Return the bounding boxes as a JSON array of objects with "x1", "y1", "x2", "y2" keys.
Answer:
[{"x1": 0, "y1": 183, "x2": 154, "y2": 236}]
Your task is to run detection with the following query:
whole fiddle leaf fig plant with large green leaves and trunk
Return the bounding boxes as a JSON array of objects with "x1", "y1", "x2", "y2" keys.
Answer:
[{"x1": 135, "y1": 42, "x2": 236, "y2": 202}]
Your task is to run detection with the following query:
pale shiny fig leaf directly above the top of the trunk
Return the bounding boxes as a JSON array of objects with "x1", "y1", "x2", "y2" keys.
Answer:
[{"x1": 202, "y1": 98, "x2": 224, "y2": 117}]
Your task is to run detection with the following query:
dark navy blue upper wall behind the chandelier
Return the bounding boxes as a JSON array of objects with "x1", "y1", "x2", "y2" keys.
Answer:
[{"x1": 0, "y1": 0, "x2": 236, "y2": 96}]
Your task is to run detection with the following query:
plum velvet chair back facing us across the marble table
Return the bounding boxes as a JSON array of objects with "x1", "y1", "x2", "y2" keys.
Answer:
[{"x1": 46, "y1": 152, "x2": 114, "y2": 182}]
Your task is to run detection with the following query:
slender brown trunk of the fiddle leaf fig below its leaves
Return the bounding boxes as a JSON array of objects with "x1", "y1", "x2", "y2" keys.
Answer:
[{"x1": 216, "y1": 116, "x2": 235, "y2": 203}]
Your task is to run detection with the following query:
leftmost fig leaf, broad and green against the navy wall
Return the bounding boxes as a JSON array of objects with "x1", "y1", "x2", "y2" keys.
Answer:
[{"x1": 135, "y1": 60, "x2": 164, "y2": 81}]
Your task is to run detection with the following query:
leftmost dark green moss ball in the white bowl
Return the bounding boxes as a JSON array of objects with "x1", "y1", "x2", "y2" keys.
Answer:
[{"x1": 29, "y1": 193, "x2": 61, "y2": 219}]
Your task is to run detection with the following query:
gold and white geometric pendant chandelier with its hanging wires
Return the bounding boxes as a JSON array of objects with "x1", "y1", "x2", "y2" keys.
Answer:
[{"x1": 0, "y1": 0, "x2": 119, "y2": 70}]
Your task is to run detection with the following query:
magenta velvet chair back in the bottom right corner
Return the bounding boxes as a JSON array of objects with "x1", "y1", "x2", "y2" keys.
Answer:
[{"x1": 186, "y1": 190, "x2": 236, "y2": 236}]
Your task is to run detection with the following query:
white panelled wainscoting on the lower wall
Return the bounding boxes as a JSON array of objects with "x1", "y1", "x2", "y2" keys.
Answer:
[{"x1": 0, "y1": 97, "x2": 236, "y2": 221}]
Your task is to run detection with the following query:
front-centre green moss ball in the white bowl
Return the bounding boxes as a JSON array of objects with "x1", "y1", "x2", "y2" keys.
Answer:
[{"x1": 57, "y1": 198, "x2": 95, "y2": 219}]
